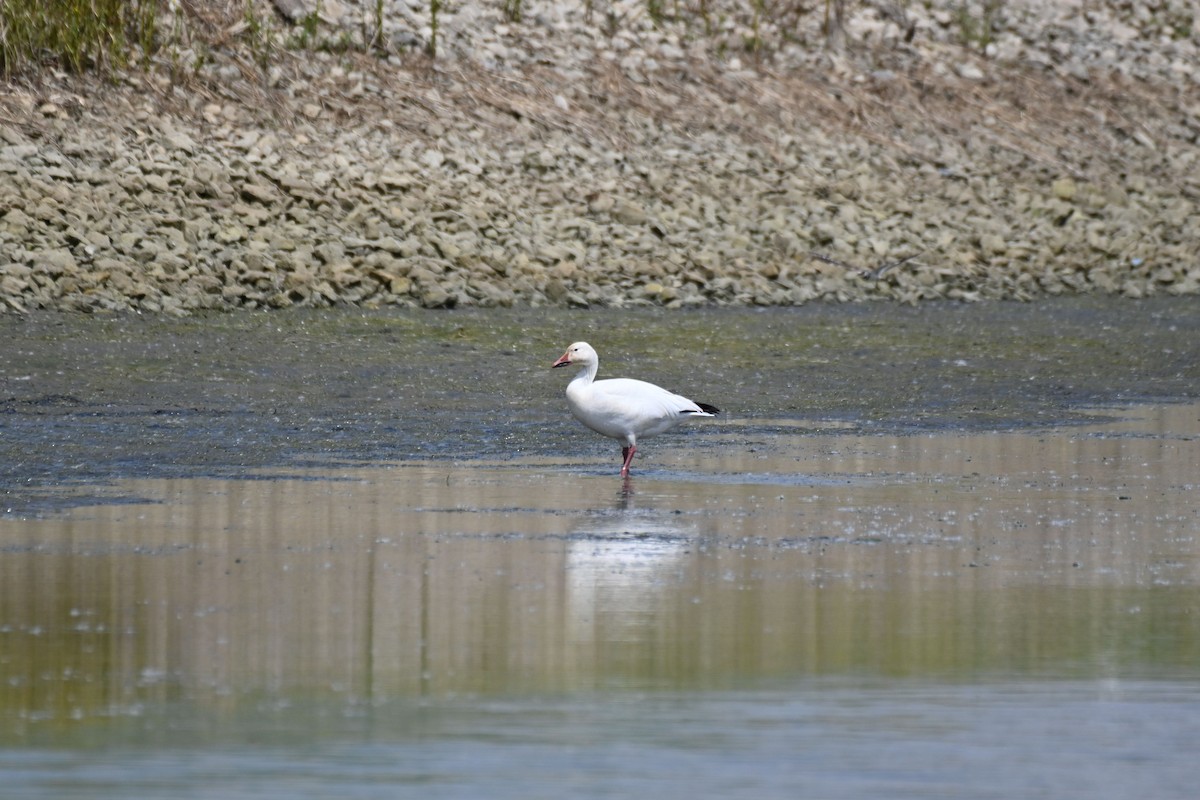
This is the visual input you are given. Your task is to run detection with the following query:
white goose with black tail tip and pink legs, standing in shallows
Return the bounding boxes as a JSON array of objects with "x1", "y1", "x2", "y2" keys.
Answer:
[{"x1": 551, "y1": 342, "x2": 720, "y2": 476}]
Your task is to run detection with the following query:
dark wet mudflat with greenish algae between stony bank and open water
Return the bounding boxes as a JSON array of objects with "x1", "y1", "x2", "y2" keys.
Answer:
[{"x1": 0, "y1": 296, "x2": 1200, "y2": 515}]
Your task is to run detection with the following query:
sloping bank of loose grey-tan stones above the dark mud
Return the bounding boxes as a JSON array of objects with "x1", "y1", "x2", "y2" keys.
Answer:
[{"x1": 0, "y1": 0, "x2": 1200, "y2": 314}]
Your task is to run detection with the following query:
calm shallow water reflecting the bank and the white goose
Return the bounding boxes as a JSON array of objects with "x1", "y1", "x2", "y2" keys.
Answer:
[{"x1": 0, "y1": 403, "x2": 1200, "y2": 799}]
